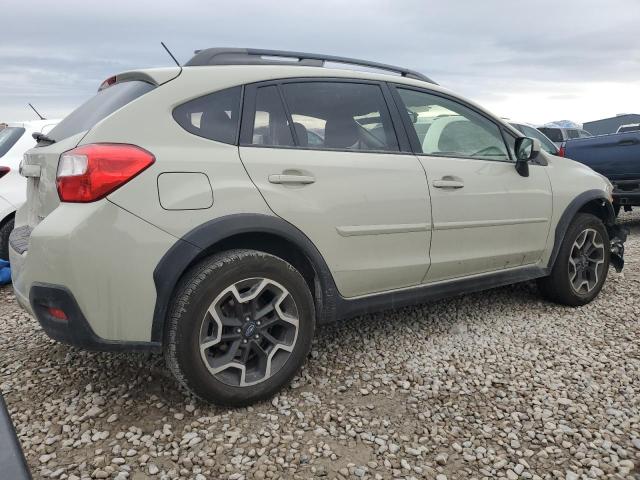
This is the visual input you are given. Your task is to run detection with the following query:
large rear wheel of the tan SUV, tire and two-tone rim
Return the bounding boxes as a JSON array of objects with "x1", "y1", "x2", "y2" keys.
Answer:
[{"x1": 165, "y1": 250, "x2": 315, "y2": 406}]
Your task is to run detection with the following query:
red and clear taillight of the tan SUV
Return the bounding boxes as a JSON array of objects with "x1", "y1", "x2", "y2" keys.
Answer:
[{"x1": 56, "y1": 143, "x2": 155, "y2": 203}]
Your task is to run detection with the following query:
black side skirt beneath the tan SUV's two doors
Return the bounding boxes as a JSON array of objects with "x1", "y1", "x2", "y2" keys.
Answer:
[{"x1": 337, "y1": 267, "x2": 549, "y2": 319}]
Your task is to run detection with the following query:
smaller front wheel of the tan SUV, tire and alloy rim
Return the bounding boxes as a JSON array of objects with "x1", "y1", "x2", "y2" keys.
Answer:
[{"x1": 538, "y1": 213, "x2": 610, "y2": 306}]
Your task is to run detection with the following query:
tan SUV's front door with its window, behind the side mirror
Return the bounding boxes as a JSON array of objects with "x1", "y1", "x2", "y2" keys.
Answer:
[{"x1": 395, "y1": 86, "x2": 552, "y2": 282}]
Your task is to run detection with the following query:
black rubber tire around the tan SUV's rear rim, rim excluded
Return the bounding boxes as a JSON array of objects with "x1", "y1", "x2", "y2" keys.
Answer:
[{"x1": 164, "y1": 250, "x2": 315, "y2": 407}]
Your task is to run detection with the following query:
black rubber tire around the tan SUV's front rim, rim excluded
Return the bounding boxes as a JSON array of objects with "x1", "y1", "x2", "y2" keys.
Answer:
[{"x1": 538, "y1": 213, "x2": 610, "y2": 307}]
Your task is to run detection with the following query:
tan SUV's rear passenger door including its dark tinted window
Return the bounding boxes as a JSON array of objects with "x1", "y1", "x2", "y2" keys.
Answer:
[{"x1": 240, "y1": 79, "x2": 431, "y2": 297}]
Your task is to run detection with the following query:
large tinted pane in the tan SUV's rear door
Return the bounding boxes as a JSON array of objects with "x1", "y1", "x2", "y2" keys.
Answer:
[{"x1": 282, "y1": 82, "x2": 399, "y2": 151}]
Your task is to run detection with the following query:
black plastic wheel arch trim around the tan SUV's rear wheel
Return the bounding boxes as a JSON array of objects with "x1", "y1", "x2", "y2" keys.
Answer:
[{"x1": 151, "y1": 214, "x2": 339, "y2": 342}]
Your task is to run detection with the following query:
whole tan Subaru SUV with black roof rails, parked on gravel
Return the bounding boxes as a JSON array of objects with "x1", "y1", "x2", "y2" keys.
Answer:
[{"x1": 10, "y1": 49, "x2": 623, "y2": 405}]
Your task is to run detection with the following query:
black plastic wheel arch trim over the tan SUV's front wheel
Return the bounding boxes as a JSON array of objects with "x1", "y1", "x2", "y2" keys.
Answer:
[{"x1": 547, "y1": 190, "x2": 616, "y2": 270}]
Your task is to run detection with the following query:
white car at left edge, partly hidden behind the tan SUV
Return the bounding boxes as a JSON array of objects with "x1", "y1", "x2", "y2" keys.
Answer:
[{"x1": 0, "y1": 120, "x2": 60, "y2": 260}]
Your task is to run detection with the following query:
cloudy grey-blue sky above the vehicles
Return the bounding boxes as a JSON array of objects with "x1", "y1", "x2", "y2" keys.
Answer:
[{"x1": 0, "y1": 0, "x2": 640, "y2": 123}]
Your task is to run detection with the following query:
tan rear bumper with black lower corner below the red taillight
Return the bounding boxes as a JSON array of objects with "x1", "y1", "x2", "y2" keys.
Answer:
[{"x1": 9, "y1": 200, "x2": 176, "y2": 350}]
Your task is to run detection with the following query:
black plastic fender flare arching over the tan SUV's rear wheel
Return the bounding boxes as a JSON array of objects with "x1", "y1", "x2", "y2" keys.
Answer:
[{"x1": 151, "y1": 213, "x2": 339, "y2": 342}]
